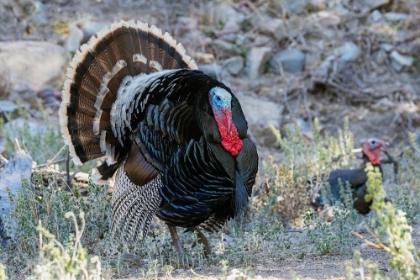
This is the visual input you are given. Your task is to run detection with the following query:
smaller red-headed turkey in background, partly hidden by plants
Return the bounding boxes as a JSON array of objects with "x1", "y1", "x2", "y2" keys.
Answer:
[{"x1": 308, "y1": 138, "x2": 385, "y2": 215}]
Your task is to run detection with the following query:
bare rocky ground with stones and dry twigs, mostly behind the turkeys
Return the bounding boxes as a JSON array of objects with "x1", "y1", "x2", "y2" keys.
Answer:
[{"x1": 0, "y1": 0, "x2": 420, "y2": 279}]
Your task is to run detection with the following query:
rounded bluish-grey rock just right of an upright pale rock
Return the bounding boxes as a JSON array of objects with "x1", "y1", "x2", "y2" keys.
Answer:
[{"x1": 270, "y1": 49, "x2": 306, "y2": 74}]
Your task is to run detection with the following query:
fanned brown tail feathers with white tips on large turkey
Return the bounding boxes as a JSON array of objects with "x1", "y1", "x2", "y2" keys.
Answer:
[{"x1": 59, "y1": 21, "x2": 197, "y2": 181}]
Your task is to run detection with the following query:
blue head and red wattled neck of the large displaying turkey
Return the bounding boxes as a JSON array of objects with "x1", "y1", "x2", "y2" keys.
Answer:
[{"x1": 209, "y1": 87, "x2": 242, "y2": 156}]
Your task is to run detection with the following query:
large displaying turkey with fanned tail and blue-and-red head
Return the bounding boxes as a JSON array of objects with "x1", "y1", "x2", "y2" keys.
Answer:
[{"x1": 60, "y1": 21, "x2": 258, "y2": 260}]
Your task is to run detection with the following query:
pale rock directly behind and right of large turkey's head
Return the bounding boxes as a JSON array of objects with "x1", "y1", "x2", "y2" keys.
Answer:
[{"x1": 236, "y1": 94, "x2": 284, "y2": 147}]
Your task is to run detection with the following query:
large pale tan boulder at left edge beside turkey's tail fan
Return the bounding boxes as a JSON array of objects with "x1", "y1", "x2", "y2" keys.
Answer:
[{"x1": 0, "y1": 41, "x2": 70, "y2": 93}]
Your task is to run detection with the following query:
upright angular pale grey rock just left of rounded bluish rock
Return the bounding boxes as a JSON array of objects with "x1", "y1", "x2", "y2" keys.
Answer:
[{"x1": 246, "y1": 47, "x2": 271, "y2": 79}]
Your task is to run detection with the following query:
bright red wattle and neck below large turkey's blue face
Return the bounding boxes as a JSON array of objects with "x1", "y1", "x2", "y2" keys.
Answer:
[{"x1": 215, "y1": 109, "x2": 242, "y2": 156}]
